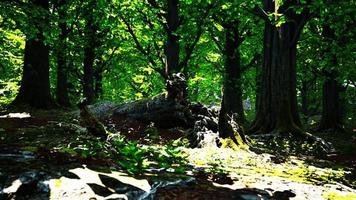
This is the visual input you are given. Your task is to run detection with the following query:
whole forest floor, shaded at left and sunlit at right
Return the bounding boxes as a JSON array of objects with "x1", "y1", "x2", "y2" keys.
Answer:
[{"x1": 0, "y1": 105, "x2": 356, "y2": 200}]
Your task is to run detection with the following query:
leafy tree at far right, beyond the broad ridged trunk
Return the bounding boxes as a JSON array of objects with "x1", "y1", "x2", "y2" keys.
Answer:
[{"x1": 299, "y1": 1, "x2": 355, "y2": 130}]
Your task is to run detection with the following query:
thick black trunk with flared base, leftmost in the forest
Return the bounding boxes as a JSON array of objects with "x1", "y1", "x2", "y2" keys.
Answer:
[{"x1": 13, "y1": 0, "x2": 53, "y2": 109}]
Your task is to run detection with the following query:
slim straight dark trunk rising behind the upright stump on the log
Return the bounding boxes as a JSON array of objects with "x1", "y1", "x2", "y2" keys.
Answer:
[{"x1": 165, "y1": 0, "x2": 180, "y2": 77}]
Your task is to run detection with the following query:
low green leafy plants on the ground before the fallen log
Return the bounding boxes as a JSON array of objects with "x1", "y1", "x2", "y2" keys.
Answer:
[{"x1": 75, "y1": 136, "x2": 187, "y2": 174}]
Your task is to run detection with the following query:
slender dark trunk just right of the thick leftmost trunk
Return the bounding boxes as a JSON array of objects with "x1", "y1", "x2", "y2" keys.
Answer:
[{"x1": 56, "y1": 0, "x2": 70, "y2": 107}]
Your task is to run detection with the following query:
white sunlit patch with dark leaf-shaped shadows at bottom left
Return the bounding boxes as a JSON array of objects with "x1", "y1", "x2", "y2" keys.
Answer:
[{"x1": 42, "y1": 165, "x2": 152, "y2": 199}]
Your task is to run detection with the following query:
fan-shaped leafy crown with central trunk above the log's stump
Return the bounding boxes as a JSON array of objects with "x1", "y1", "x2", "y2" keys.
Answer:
[{"x1": 120, "y1": 0, "x2": 214, "y2": 97}]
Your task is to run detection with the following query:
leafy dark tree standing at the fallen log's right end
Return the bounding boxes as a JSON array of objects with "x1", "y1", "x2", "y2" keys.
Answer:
[{"x1": 206, "y1": 1, "x2": 257, "y2": 141}]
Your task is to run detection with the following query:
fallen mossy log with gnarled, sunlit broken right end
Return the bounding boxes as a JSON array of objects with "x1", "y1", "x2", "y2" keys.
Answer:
[{"x1": 113, "y1": 95, "x2": 218, "y2": 147}]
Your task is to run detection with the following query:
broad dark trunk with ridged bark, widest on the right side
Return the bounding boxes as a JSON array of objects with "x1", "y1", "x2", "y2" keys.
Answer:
[{"x1": 249, "y1": 0, "x2": 307, "y2": 135}]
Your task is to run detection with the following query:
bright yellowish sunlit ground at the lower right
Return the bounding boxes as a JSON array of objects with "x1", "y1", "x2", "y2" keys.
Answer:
[{"x1": 187, "y1": 148, "x2": 356, "y2": 200}]
